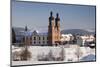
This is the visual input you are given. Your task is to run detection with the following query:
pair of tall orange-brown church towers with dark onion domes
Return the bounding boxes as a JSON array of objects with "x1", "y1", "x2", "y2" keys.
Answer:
[{"x1": 48, "y1": 11, "x2": 60, "y2": 45}]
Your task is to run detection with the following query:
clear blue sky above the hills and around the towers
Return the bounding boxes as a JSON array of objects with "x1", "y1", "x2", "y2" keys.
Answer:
[{"x1": 12, "y1": 1, "x2": 96, "y2": 30}]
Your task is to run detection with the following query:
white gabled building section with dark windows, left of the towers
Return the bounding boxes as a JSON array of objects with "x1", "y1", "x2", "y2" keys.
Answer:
[{"x1": 32, "y1": 30, "x2": 48, "y2": 46}]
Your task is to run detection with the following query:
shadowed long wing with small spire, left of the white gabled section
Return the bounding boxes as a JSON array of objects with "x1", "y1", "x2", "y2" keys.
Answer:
[{"x1": 15, "y1": 26, "x2": 32, "y2": 46}]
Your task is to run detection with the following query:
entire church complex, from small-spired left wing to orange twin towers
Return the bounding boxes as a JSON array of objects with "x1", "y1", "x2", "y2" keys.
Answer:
[{"x1": 13, "y1": 11, "x2": 61, "y2": 46}]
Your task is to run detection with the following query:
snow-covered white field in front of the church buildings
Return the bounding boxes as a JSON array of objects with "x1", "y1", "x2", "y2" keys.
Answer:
[{"x1": 12, "y1": 45, "x2": 95, "y2": 65}]
